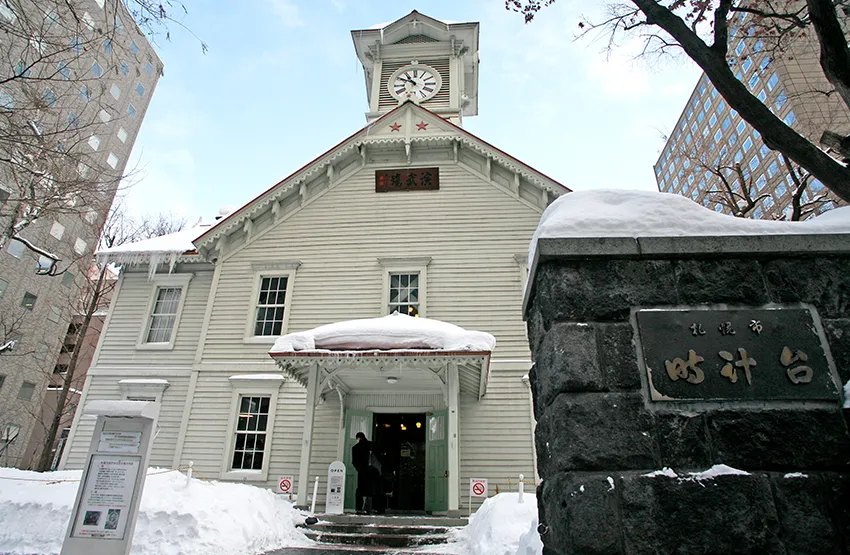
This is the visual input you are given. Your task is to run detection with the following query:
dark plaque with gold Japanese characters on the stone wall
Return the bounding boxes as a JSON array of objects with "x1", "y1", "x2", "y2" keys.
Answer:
[{"x1": 635, "y1": 307, "x2": 839, "y2": 401}]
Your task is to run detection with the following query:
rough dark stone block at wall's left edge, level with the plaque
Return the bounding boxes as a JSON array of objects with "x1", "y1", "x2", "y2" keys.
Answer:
[{"x1": 534, "y1": 324, "x2": 605, "y2": 407}]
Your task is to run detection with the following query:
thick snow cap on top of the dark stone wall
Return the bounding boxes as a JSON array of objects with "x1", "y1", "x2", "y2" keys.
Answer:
[{"x1": 528, "y1": 189, "x2": 850, "y2": 261}]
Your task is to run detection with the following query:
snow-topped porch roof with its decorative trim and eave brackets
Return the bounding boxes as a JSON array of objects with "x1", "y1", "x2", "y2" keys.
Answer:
[{"x1": 269, "y1": 313, "x2": 496, "y2": 398}]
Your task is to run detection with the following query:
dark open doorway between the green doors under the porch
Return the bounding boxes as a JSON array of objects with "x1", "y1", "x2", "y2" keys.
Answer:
[{"x1": 374, "y1": 413, "x2": 427, "y2": 513}]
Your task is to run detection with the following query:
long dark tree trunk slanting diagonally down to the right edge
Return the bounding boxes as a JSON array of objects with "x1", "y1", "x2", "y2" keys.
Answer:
[{"x1": 631, "y1": 0, "x2": 850, "y2": 202}]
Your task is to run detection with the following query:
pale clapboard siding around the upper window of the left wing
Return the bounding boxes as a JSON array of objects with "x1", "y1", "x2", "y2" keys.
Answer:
[{"x1": 95, "y1": 270, "x2": 213, "y2": 367}]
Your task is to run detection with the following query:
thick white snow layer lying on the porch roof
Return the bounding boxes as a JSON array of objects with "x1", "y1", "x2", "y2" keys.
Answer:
[{"x1": 269, "y1": 313, "x2": 496, "y2": 356}]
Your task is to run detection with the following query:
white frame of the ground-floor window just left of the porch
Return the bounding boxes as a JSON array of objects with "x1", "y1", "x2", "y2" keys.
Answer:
[{"x1": 220, "y1": 378, "x2": 285, "y2": 482}]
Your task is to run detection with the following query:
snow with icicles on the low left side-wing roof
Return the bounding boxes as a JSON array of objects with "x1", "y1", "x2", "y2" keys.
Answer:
[{"x1": 95, "y1": 224, "x2": 212, "y2": 275}]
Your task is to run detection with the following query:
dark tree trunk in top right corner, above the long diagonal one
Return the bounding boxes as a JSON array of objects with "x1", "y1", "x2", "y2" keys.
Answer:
[{"x1": 806, "y1": 0, "x2": 850, "y2": 109}]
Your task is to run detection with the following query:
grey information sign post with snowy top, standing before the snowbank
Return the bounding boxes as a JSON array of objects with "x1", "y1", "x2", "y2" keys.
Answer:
[{"x1": 61, "y1": 401, "x2": 159, "y2": 555}]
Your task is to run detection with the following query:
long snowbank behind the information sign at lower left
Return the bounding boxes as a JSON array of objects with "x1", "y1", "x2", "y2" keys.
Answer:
[{"x1": 0, "y1": 468, "x2": 312, "y2": 555}]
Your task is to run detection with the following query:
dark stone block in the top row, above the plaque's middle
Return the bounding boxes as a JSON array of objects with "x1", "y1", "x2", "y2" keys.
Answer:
[{"x1": 673, "y1": 258, "x2": 768, "y2": 305}]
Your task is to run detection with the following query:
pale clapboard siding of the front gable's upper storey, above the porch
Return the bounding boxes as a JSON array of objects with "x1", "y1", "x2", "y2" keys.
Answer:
[{"x1": 204, "y1": 164, "x2": 540, "y2": 360}]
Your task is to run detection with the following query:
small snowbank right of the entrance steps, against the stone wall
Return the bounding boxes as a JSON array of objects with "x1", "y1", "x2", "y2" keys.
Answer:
[{"x1": 448, "y1": 493, "x2": 543, "y2": 555}]
